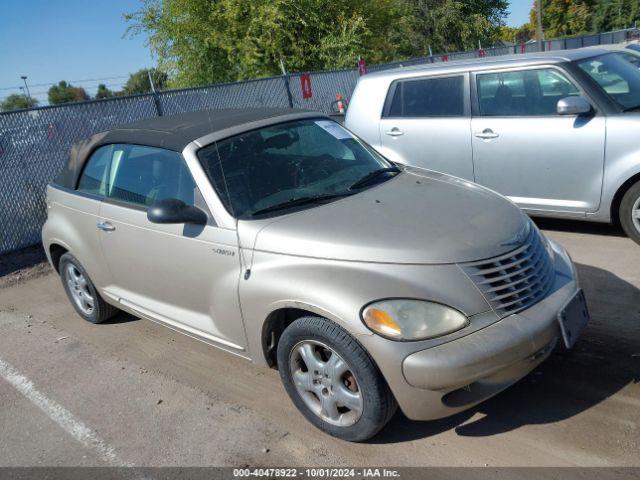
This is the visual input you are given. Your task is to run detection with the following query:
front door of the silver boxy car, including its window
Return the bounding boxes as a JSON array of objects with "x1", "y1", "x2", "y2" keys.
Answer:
[{"x1": 471, "y1": 66, "x2": 606, "y2": 215}]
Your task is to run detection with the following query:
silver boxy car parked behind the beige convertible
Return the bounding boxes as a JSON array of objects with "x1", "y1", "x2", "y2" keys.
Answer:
[{"x1": 345, "y1": 48, "x2": 640, "y2": 243}]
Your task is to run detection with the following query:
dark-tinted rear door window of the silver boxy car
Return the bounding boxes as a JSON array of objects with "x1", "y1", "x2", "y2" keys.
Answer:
[{"x1": 383, "y1": 75, "x2": 465, "y2": 118}]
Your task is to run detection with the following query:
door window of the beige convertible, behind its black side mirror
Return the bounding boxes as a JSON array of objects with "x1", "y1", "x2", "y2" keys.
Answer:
[{"x1": 107, "y1": 145, "x2": 196, "y2": 206}]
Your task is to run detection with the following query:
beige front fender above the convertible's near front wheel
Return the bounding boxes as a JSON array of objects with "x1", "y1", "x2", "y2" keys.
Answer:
[{"x1": 239, "y1": 251, "x2": 489, "y2": 364}]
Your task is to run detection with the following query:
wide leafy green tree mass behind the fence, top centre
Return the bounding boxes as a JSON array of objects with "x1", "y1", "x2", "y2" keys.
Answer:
[{"x1": 126, "y1": 0, "x2": 507, "y2": 87}]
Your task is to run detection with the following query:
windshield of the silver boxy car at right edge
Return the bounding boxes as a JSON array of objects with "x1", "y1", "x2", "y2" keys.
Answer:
[{"x1": 578, "y1": 53, "x2": 640, "y2": 110}]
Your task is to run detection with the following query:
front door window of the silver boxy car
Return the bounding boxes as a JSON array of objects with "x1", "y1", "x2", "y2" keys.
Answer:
[{"x1": 476, "y1": 68, "x2": 580, "y2": 117}]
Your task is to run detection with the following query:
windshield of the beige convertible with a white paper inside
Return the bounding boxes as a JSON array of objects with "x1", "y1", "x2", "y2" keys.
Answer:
[{"x1": 198, "y1": 119, "x2": 399, "y2": 219}]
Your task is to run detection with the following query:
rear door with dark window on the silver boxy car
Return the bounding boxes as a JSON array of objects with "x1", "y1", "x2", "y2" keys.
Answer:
[{"x1": 380, "y1": 73, "x2": 473, "y2": 180}]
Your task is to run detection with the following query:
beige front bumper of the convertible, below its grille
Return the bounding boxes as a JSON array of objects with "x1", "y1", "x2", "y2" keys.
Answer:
[{"x1": 364, "y1": 240, "x2": 578, "y2": 420}]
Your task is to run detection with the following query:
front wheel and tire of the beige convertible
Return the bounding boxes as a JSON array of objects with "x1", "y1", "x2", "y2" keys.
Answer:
[{"x1": 278, "y1": 317, "x2": 397, "y2": 442}]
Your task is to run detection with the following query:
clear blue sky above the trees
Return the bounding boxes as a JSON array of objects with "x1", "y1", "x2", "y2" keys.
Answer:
[{"x1": 0, "y1": 0, "x2": 533, "y2": 105}]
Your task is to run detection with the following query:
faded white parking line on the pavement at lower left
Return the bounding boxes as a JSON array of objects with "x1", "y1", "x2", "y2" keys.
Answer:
[{"x1": 0, "y1": 358, "x2": 131, "y2": 467}]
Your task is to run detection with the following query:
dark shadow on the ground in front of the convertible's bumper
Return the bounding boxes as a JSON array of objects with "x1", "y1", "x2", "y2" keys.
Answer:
[{"x1": 371, "y1": 264, "x2": 640, "y2": 443}]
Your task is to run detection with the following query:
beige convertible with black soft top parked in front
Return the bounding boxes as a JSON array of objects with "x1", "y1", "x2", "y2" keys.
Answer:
[{"x1": 42, "y1": 109, "x2": 588, "y2": 440}]
